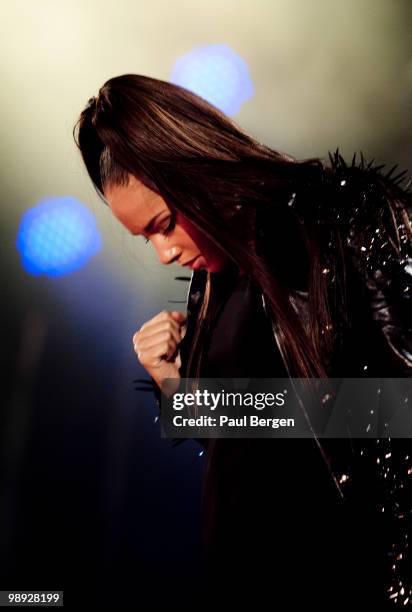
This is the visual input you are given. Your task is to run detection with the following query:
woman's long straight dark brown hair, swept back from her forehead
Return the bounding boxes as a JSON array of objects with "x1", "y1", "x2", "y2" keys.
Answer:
[{"x1": 73, "y1": 74, "x2": 412, "y2": 378}]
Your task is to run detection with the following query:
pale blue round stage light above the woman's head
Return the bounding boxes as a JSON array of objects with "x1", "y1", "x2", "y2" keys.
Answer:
[{"x1": 170, "y1": 44, "x2": 255, "y2": 116}]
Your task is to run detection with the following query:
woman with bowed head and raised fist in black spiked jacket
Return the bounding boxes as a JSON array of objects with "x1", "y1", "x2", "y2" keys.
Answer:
[{"x1": 75, "y1": 75, "x2": 412, "y2": 608}]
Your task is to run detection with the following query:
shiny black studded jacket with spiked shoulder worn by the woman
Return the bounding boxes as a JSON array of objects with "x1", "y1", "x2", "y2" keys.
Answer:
[{"x1": 139, "y1": 151, "x2": 412, "y2": 603}]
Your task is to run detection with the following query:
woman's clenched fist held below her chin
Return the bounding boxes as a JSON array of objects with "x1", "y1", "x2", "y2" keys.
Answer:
[{"x1": 133, "y1": 310, "x2": 187, "y2": 392}]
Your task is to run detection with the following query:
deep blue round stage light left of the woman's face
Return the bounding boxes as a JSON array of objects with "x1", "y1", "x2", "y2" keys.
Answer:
[{"x1": 16, "y1": 196, "x2": 102, "y2": 277}]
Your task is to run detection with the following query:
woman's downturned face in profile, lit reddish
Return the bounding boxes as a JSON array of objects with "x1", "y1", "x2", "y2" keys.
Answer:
[{"x1": 104, "y1": 175, "x2": 230, "y2": 272}]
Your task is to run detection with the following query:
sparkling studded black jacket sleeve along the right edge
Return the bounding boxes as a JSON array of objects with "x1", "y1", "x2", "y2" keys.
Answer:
[{"x1": 320, "y1": 152, "x2": 412, "y2": 603}]
